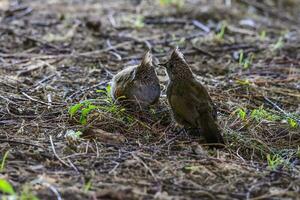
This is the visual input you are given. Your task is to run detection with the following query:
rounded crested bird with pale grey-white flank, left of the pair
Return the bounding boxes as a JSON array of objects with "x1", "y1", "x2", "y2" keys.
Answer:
[{"x1": 111, "y1": 50, "x2": 160, "y2": 108}]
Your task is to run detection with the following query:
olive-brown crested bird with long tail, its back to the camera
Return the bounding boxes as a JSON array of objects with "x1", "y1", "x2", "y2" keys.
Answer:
[{"x1": 161, "y1": 47, "x2": 224, "y2": 144}]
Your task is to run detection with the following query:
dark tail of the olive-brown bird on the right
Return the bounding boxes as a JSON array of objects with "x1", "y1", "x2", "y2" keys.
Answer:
[{"x1": 198, "y1": 112, "x2": 224, "y2": 144}]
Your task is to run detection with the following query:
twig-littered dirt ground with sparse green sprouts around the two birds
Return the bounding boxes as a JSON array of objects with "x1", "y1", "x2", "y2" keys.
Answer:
[{"x1": 0, "y1": 0, "x2": 300, "y2": 200}]
